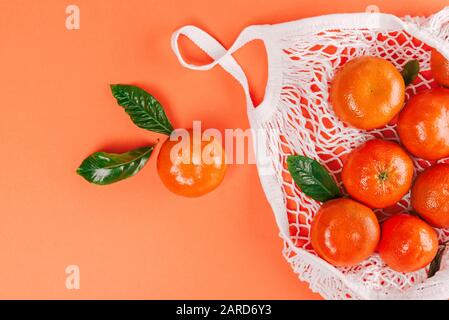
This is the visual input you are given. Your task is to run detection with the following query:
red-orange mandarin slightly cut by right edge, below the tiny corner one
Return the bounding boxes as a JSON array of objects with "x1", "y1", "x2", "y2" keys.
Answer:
[{"x1": 397, "y1": 88, "x2": 449, "y2": 160}]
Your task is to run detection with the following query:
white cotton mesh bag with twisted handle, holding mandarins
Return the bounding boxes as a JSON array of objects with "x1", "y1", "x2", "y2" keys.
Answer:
[{"x1": 172, "y1": 7, "x2": 449, "y2": 299}]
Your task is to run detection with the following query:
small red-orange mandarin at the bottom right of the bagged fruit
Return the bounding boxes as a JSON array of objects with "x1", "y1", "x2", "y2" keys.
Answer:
[{"x1": 378, "y1": 214, "x2": 438, "y2": 272}]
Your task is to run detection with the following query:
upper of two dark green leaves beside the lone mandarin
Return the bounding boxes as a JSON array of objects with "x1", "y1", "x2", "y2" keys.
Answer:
[{"x1": 111, "y1": 84, "x2": 173, "y2": 136}]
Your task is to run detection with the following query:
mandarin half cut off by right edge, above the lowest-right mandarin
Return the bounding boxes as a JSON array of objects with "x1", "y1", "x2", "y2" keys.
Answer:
[{"x1": 411, "y1": 164, "x2": 449, "y2": 228}]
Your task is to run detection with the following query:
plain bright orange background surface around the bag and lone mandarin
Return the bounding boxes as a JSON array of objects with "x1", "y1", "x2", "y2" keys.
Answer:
[{"x1": 0, "y1": 0, "x2": 449, "y2": 299}]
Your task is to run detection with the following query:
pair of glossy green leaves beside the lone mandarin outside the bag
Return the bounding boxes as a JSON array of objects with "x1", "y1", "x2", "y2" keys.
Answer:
[{"x1": 77, "y1": 85, "x2": 173, "y2": 185}]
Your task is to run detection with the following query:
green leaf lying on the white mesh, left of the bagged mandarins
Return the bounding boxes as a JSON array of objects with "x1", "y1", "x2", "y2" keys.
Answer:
[{"x1": 287, "y1": 156, "x2": 341, "y2": 202}]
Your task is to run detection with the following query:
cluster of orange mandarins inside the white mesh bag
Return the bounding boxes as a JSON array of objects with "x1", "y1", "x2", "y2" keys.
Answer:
[{"x1": 311, "y1": 50, "x2": 449, "y2": 272}]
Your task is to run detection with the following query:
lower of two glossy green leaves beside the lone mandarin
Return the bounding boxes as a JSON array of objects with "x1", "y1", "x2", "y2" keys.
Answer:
[{"x1": 76, "y1": 146, "x2": 154, "y2": 185}]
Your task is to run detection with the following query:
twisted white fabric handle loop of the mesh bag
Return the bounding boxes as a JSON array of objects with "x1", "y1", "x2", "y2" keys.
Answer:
[{"x1": 171, "y1": 25, "x2": 266, "y2": 109}]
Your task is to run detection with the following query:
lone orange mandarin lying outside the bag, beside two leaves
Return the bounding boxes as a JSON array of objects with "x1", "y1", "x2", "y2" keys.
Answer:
[{"x1": 157, "y1": 130, "x2": 227, "y2": 197}]
